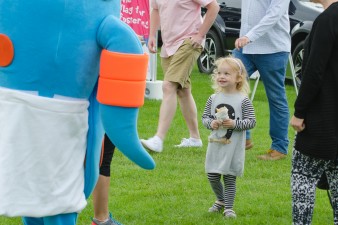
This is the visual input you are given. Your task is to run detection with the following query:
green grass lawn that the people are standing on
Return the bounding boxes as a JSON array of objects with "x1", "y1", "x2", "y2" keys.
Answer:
[{"x1": 0, "y1": 57, "x2": 333, "y2": 225}]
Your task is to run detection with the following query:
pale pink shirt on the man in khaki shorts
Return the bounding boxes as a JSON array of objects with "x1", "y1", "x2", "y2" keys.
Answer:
[{"x1": 151, "y1": 0, "x2": 213, "y2": 58}]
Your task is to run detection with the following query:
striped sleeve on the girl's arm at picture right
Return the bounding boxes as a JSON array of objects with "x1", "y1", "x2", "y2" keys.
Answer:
[{"x1": 234, "y1": 97, "x2": 256, "y2": 130}]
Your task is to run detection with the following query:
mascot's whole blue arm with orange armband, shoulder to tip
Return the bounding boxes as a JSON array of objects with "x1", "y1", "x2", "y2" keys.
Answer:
[{"x1": 96, "y1": 16, "x2": 155, "y2": 172}]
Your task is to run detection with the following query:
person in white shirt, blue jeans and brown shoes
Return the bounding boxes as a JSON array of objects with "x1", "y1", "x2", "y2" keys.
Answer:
[{"x1": 233, "y1": 0, "x2": 291, "y2": 160}]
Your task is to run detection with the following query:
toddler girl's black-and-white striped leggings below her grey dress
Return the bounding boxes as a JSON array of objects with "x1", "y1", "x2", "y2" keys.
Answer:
[{"x1": 207, "y1": 173, "x2": 236, "y2": 209}]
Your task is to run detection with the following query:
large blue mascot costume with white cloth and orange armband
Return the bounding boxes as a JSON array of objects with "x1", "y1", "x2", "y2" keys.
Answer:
[{"x1": 0, "y1": 0, "x2": 155, "y2": 225}]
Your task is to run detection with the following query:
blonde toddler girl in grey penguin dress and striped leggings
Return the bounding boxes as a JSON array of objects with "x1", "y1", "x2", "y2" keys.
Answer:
[{"x1": 202, "y1": 56, "x2": 256, "y2": 218}]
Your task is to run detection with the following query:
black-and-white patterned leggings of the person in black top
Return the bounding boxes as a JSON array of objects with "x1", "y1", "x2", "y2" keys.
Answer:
[{"x1": 291, "y1": 150, "x2": 338, "y2": 225}]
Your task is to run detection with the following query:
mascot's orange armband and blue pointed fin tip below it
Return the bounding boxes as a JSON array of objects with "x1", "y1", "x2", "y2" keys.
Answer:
[{"x1": 97, "y1": 50, "x2": 155, "y2": 169}]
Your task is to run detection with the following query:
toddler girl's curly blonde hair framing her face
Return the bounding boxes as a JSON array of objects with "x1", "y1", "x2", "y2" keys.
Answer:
[{"x1": 211, "y1": 55, "x2": 250, "y2": 95}]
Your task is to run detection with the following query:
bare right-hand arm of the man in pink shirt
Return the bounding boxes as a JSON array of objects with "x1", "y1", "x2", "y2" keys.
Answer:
[{"x1": 191, "y1": 0, "x2": 219, "y2": 47}]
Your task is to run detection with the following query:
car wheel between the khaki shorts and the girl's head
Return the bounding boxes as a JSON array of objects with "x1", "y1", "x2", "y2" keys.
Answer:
[{"x1": 197, "y1": 30, "x2": 222, "y2": 74}]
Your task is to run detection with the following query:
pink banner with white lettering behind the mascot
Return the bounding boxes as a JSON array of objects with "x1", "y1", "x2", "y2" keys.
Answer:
[{"x1": 121, "y1": 0, "x2": 150, "y2": 40}]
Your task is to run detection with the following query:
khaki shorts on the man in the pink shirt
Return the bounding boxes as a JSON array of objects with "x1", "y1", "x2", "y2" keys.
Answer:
[{"x1": 161, "y1": 38, "x2": 203, "y2": 88}]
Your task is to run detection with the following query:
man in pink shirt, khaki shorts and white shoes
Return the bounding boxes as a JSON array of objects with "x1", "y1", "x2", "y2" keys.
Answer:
[{"x1": 141, "y1": 0, "x2": 219, "y2": 152}]
